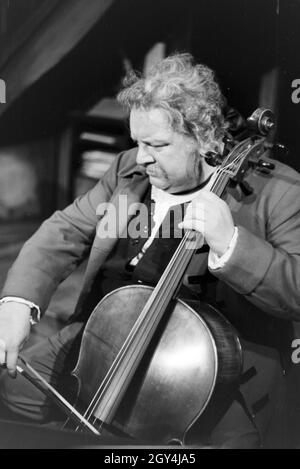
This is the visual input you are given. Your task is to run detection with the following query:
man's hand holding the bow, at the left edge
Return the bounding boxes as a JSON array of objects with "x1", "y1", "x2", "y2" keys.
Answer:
[{"x1": 0, "y1": 301, "x2": 30, "y2": 377}]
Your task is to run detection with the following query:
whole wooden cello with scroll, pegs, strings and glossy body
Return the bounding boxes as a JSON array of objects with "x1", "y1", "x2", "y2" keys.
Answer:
[{"x1": 19, "y1": 109, "x2": 274, "y2": 445}]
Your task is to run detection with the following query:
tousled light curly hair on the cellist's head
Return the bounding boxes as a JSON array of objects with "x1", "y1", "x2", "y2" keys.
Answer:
[{"x1": 117, "y1": 53, "x2": 227, "y2": 152}]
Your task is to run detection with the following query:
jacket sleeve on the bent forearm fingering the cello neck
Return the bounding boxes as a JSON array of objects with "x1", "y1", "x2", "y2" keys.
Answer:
[{"x1": 212, "y1": 184, "x2": 300, "y2": 321}]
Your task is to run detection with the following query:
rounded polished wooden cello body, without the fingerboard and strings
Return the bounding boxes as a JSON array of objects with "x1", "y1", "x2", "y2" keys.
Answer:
[{"x1": 73, "y1": 285, "x2": 242, "y2": 444}]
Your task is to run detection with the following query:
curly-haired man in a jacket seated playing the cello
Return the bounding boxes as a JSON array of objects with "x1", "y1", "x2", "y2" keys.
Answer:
[{"x1": 0, "y1": 54, "x2": 300, "y2": 448}]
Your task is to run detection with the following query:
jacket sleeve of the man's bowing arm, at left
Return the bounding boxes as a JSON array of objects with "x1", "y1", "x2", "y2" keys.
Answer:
[{"x1": 1, "y1": 153, "x2": 124, "y2": 311}]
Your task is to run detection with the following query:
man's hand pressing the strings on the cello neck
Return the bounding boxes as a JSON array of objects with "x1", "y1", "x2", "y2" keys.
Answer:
[{"x1": 179, "y1": 191, "x2": 234, "y2": 257}]
